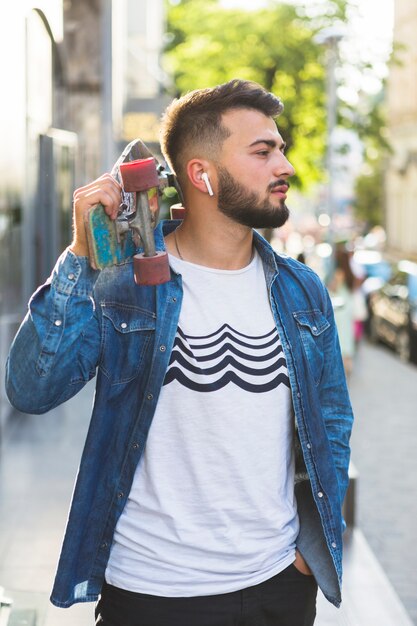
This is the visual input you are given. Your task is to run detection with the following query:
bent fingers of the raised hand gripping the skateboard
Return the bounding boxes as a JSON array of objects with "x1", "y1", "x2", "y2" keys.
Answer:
[{"x1": 74, "y1": 174, "x2": 122, "y2": 220}]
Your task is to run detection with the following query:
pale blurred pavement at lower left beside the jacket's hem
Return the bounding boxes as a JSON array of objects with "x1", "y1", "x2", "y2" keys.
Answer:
[{"x1": 0, "y1": 383, "x2": 94, "y2": 626}]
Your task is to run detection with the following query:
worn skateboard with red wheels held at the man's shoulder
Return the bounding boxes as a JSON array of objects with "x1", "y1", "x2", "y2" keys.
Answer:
[{"x1": 84, "y1": 139, "x2": 184, "y2": 285}]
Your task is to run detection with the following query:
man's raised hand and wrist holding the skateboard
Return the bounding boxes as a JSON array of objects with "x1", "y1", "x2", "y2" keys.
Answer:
[{"x1": 70, "y1": 174, "x2": 122, "y2": 256}]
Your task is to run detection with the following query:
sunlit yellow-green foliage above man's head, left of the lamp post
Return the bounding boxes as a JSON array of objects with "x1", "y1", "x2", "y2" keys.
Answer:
[{"x1": 165, "y1": 0, "x2": 346, "y2": 189}]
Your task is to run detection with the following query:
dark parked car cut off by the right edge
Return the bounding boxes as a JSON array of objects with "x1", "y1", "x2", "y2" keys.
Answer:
[{"x1": 369, "y1": 261, "x2": 417, "y2": 363}]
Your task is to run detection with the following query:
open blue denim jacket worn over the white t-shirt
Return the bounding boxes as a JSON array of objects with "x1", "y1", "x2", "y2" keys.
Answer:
[{"x1": 6, "y1": 222, "x2": 353, "y2": 607}]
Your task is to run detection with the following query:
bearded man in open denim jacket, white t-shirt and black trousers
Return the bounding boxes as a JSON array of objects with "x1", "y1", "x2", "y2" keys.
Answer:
[{"x1": 7, "y1": 80, "x2": 352, "y2": 626}]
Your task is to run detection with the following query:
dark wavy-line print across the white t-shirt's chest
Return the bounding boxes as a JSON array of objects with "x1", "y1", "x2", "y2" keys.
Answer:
[{"x1": 164, "y1": 324, "x2": 290, "y2": 393}]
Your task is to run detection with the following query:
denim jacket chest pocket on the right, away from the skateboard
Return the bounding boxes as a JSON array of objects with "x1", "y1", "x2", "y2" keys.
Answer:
[{"x1": 293, "y1": 309, "x2": 330, "y2": 385}]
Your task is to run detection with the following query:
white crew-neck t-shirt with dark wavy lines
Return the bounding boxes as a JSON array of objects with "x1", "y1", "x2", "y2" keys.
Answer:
[{"x1": 106, "y1": 249, "x2": 299, "y2": 596}]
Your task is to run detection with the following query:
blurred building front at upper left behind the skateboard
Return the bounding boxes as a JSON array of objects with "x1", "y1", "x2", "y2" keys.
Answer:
[{"x1": 0, "y1": 0, "x2": 164, "y2": 439}]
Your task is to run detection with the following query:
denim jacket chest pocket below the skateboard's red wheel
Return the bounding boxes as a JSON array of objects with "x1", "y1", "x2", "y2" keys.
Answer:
[{"x1": 101, "y1": 303, "x2": 156, "y2": 384}]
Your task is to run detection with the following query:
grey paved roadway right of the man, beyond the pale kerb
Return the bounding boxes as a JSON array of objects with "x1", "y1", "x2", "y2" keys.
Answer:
[{"x1": 350, "y1": 343, "x2": 417, "y2": 624}]
